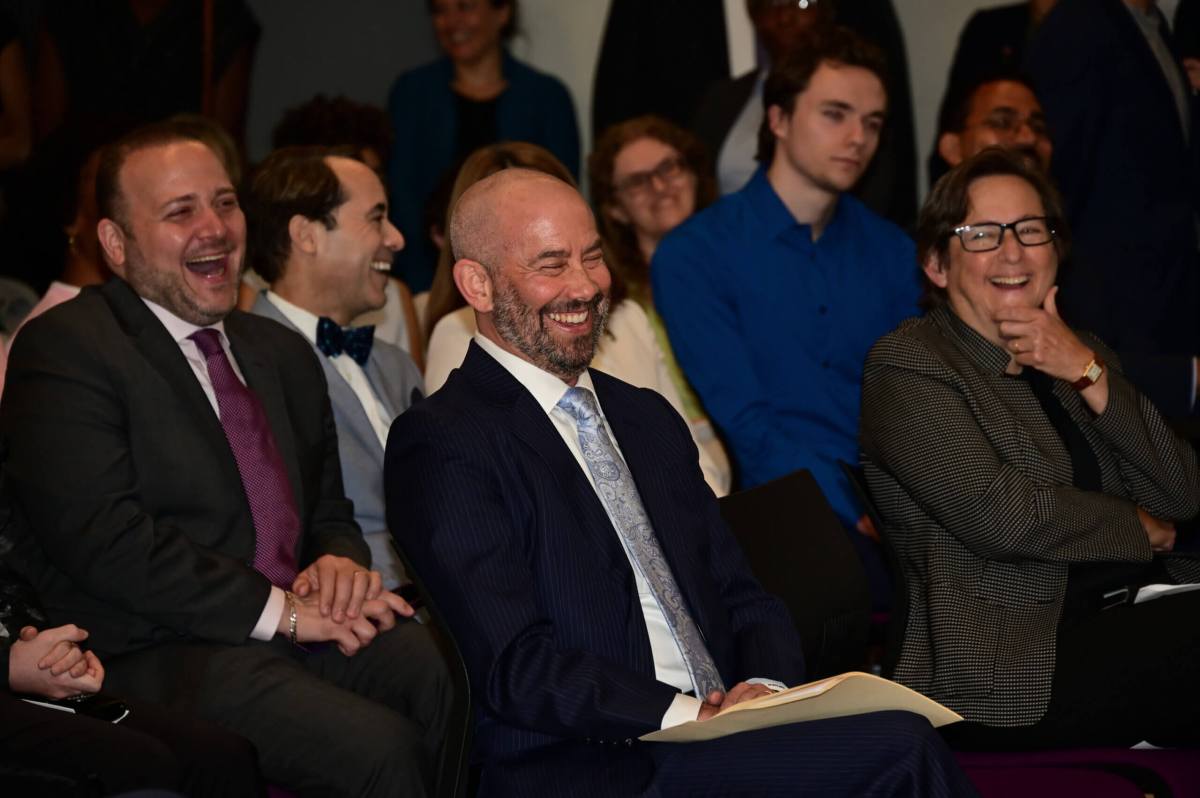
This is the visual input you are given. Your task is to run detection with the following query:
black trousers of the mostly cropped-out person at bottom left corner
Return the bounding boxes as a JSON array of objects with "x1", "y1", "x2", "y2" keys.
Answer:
[{"x1": 0, "y1": 691, "x2": 263, "y2": 798}]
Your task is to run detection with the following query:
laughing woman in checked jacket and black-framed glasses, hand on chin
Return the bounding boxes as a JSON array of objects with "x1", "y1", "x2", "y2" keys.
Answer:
[{"x1": 860, "y1": 149, "x2": 1200, "y2": 749}]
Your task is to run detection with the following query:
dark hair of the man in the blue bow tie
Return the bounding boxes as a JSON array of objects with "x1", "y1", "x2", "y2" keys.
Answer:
[{"x1": 242, "y1": 146, "x2": 358, "y2": 283}]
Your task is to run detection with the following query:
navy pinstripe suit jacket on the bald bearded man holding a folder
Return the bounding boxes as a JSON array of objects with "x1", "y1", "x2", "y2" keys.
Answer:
[{"x1": 385, "y1": 343, "x2": 803, "y2": 762}]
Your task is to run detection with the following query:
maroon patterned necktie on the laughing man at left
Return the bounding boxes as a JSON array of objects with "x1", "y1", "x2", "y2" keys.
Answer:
[{"x1": 191, "y1": 329, "x2": 300, "y2": 589}]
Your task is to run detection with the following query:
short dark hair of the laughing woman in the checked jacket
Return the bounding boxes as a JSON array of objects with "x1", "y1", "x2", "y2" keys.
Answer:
[{"x1": 916, "y1": 146, "x2": 1070, "y2": 310}]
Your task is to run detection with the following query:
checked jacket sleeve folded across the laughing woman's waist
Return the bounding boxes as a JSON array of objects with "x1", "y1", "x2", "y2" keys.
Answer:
[{"x1": 862, "y1": 334, "x2": 1166, "y2": 563}]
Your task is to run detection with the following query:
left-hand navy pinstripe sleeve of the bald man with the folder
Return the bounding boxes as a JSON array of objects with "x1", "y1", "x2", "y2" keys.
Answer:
[{"x1": 385, "y1": 406, "x2": 677, "y2": 739}]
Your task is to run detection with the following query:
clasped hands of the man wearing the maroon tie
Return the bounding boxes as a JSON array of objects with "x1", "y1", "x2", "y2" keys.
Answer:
[{"x1": 280, "y1": 554, "x2": 413, "y2": 656}]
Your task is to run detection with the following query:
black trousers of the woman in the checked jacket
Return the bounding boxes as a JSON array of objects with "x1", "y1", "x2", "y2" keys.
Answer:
[{"x1": 942, "y1": 590, "x2": 1200, "y2": 750}]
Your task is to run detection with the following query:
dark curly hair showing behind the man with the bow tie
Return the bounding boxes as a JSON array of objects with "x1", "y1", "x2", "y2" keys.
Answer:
[{"x1": 271, "y1": 95, "x2": 392, "y2": 163}]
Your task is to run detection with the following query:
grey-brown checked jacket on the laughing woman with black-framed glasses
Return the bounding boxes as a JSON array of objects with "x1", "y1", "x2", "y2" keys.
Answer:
[{"x1": 860, "y1": 308, "x2": 1200, "y2": 726}]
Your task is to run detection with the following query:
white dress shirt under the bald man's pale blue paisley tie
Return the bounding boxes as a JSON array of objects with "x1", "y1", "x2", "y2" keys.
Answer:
[{"x1": 475, "y1": 334, "x2": 701, "y2": 728}]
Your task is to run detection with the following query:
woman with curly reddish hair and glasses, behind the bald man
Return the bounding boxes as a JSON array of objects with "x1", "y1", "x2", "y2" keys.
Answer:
[{"x1": 588, "y1": 115, "x2": 732, "y2": 488}]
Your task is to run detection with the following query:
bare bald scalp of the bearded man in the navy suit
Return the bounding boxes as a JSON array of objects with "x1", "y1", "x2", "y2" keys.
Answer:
[{"x1": 450, "y1": 168, "x2": 583, "y2": 270}]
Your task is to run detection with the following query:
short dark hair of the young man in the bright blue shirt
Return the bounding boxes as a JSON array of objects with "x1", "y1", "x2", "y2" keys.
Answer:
[{"x1": 755, "y1": 25, "x2": 888, "y2": 164}]
